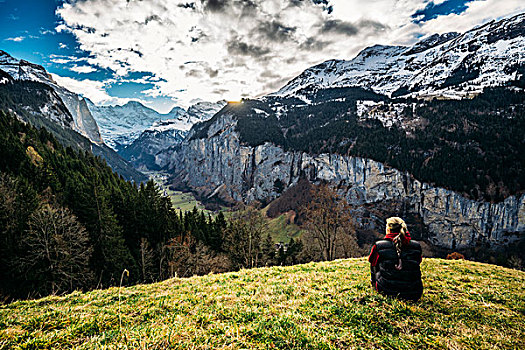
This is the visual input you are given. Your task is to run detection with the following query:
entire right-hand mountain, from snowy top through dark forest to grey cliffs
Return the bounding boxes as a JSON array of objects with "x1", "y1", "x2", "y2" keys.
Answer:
[{"x1": 164, "y1": 14, "x2": 525, "y2": 253}]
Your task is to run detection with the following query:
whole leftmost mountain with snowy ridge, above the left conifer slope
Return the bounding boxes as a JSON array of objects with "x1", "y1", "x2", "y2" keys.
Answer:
[{"x1": 0, "y1": 51, "x2": 146, "y2": 182}]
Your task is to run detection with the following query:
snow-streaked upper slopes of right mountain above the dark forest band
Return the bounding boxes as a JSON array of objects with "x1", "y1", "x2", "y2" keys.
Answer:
[{"x1": 270, "y1": 14, "x2": 525, "y2": 100}]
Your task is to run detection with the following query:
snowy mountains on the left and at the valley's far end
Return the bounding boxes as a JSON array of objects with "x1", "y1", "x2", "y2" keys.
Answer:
[{"x1": 0, "y1": 51, "x2": 226, "y2": 182}]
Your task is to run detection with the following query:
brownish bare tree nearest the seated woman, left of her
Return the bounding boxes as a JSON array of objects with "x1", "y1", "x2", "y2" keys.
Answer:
[{"x1": 302, "y1": 184, "x2": 358, "y2": 260}]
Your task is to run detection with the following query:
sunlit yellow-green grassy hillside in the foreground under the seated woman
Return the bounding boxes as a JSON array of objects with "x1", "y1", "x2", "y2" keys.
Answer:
[{"x1": 0, "y1": 259, "x2": 525, "y2": 349}]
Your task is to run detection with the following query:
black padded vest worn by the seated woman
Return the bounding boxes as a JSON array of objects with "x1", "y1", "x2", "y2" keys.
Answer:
[{"x1": 372, "y1": 240, "x2": 423, "y2": 300}]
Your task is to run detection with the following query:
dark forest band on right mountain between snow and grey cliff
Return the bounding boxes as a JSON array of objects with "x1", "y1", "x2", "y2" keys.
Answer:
[{"x1": 210, "y1": 87, "x2": 525, "y2": 202}]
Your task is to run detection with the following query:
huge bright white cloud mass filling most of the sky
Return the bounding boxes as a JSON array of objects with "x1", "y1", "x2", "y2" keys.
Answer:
[{"x1": 55, "y1": 0, "x2": 525, "y2": 105}]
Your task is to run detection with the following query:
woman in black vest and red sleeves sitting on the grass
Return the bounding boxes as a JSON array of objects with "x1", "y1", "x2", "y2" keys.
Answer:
[{"x1": 368, "y1": 217, "x2": 423, "y2": 301}]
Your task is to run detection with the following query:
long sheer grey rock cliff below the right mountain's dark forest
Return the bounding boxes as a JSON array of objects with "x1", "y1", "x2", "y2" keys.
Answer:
[{"x1": 171, "y1": 115, "x2": 525, "y2": 249}]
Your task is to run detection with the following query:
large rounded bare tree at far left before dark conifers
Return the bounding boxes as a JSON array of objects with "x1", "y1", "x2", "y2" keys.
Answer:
[{"x1": 21, "y1": 204, "x2": 92, "y2": 293}]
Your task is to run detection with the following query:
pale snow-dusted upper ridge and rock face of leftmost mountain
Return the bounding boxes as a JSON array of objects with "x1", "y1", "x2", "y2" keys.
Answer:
[{"x1": 0, "y1": 50, "x2": 103, "y2": 145}]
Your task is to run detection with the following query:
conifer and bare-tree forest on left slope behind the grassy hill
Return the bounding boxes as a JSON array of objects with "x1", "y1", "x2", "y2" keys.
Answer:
[{"x1": 0, "y1": 111, "x2": 312, "y2": 301}]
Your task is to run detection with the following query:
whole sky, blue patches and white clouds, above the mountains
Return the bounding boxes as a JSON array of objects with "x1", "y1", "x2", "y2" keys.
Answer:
[{"x1": 0, "y1": 0, "x2": 525, "y2": 113}]
